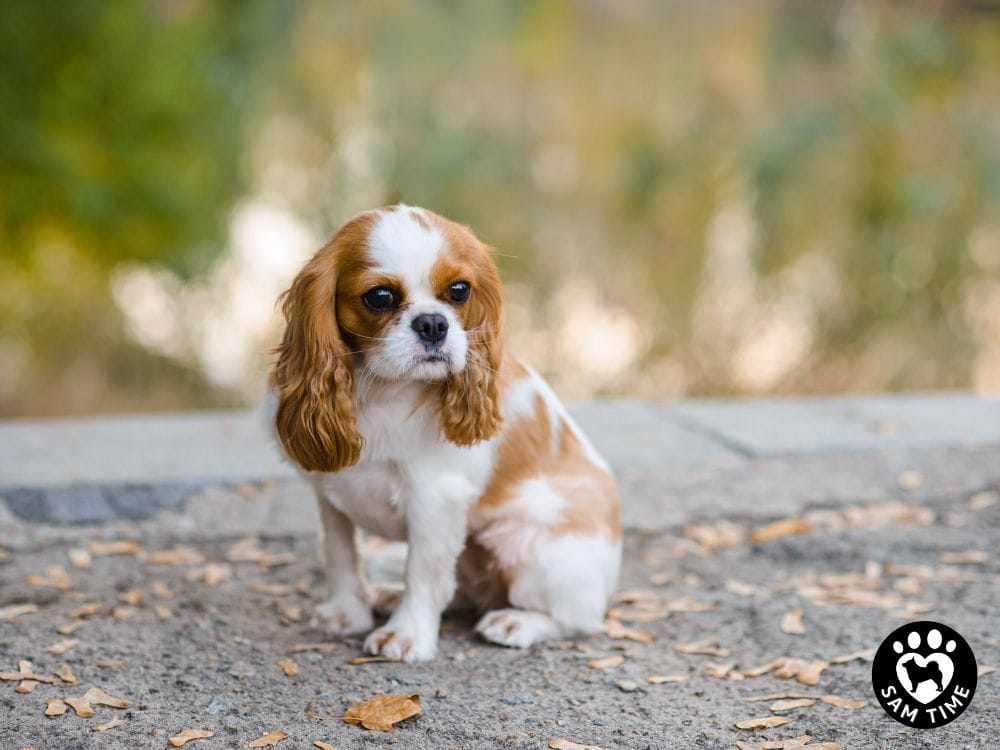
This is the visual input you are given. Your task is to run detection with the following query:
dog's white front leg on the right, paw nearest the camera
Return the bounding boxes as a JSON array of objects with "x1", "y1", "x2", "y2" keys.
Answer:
[{"x1": 365, "y1": 476, "x2": 475, "y2": 661}]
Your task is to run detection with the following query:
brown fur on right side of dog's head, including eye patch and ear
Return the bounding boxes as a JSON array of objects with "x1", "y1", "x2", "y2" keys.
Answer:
[{"x1": 429, "y1": 214, "x2": 503, "y2": 445}]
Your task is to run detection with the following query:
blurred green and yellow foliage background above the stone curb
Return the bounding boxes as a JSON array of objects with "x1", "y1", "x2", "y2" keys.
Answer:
[{"x1": 0, "y1": 0, "x2": 1000, "y2": 415}]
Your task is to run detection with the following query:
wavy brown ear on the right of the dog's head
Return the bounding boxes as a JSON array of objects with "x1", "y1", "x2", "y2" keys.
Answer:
[{"x1": 441, "y1": 256, "x2": 503, "y2": 445}]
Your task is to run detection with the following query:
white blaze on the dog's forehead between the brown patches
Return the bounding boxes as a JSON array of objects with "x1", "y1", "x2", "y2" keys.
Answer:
[{"x1": 368, "y1": 210, "x2": 445, "y2": 294}]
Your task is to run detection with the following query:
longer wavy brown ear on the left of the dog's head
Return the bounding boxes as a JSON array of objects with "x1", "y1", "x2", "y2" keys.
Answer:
[{"x1": 271, "y1": 246, "x2": 362, "y2": 471}]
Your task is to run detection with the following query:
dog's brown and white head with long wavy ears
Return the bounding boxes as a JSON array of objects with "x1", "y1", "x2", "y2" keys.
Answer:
[{"x1": 272, "y1": 206, "x2": 502, "y2": 471}]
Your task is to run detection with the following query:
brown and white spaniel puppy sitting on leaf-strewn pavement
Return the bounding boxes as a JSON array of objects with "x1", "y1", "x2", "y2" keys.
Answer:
[{"x1": 271, "y1": 205, "x2": 622, "y2": 661}]
